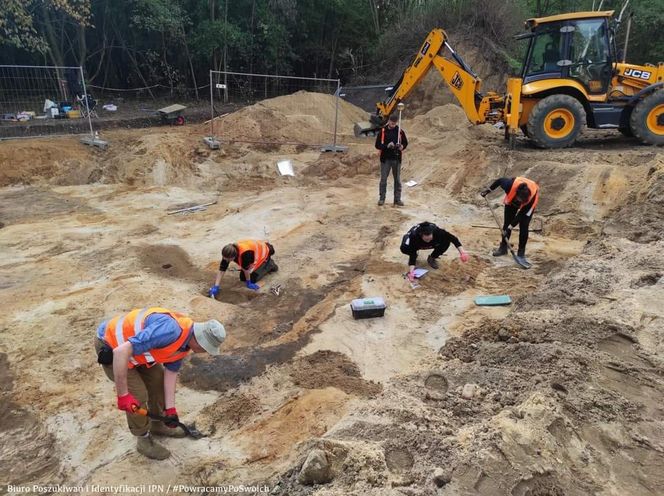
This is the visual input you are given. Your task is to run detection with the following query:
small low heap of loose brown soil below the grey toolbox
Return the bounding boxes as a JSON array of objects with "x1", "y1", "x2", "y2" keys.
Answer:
[{"x1": 290, "y1": 350, "x2": 381, "y2": 397}]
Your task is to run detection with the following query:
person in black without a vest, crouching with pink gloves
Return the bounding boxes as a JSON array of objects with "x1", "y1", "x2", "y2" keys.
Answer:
[{"x1": 401, "y1": 222, "x2": 470, "y2": 282}]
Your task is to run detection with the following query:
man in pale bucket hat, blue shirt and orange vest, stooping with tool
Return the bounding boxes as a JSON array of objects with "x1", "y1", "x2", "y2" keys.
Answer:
[{"x1": 94, "y1": 307, "x2": 226, "y2": 460}]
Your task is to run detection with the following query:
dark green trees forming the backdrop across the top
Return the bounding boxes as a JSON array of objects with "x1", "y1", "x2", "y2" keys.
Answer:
[{"x1": 0, "y1": 0, "x2": 664, "y2": 94}]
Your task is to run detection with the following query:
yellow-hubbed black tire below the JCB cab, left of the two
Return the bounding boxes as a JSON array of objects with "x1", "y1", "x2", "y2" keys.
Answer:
[{"x1": 527, "y1": 95, "x2": 586, "y2": 148}]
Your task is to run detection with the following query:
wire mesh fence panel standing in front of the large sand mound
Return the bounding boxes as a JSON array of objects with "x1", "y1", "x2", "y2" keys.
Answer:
[{"x1": 209, "y1": 71, "x2": 341, "y2": 151}]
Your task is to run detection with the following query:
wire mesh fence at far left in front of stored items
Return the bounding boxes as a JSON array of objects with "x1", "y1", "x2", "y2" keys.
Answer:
[{"x1": 0, "y1": 65, "x2": 97, "y2": 139}]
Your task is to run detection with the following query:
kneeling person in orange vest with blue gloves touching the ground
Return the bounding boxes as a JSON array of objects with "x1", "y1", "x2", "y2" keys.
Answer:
[{"x1": 208, "y1": 239, "x2": 279, "y2": 298}]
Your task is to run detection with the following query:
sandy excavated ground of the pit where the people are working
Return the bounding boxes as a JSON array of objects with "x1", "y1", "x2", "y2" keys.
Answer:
[{"x1": 0, "y1": 94, "x2": 664, "y2": 496}]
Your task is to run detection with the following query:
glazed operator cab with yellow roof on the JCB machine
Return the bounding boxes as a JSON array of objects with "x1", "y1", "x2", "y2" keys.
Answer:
[{"x1": 519, "y1": 11, "x2": 615, "y2": 95}]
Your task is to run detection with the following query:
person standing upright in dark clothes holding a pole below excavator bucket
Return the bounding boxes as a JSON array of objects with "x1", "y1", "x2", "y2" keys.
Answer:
[{"x1": 376, "y1": 114, "x2": 408, "y2": 207}]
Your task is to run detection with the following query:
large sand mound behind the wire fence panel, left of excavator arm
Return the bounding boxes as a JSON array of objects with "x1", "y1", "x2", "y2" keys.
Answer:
[{"x1": 215, "y1": 91, "x2": 366, "y2": 144}]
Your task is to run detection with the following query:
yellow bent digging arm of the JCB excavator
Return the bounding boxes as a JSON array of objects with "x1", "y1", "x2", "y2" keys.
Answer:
[{"x1": 355, "y1": 29, "x2": 504, "y2": 136}]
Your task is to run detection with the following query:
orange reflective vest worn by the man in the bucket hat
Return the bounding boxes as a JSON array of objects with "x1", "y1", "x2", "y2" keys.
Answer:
[{"x1": 104, "y1": 307, "x2": 194, "y2": 369}]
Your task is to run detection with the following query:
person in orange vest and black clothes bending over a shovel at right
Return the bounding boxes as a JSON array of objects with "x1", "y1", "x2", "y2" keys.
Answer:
[{"x1": 480, "y1": 177, "x2": 540, "y2": 264}]
